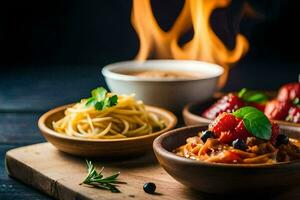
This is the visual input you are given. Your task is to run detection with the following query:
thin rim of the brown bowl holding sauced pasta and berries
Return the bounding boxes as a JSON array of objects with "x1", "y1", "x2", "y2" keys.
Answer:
[{"x1": 153, "y1": 125, "x2": 300, "y2": 168}]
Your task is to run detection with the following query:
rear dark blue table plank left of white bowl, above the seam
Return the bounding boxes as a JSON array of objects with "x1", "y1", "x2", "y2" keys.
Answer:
[{"x1": 0, "y1": 64, "x2": 105, "y2": 112}]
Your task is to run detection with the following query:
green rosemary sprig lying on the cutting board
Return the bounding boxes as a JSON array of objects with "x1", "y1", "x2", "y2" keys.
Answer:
[{"x1": 80, "y1": 160, "x2": 125, "y2": 193}]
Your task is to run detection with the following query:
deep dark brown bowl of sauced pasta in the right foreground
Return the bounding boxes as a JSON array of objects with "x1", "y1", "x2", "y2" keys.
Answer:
[{"x1": 153, "y1": 126, "x2": 300, "y2": 195}]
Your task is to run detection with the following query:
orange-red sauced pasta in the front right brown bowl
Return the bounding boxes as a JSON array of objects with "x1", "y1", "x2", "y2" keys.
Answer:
[{"x1": 174, "y1": 132, "x2": 300, "y2": 164}]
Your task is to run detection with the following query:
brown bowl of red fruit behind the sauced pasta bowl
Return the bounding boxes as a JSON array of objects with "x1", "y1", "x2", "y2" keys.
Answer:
[{"x1": 182, "y1": 98, "x2": 300, "y2": 131}]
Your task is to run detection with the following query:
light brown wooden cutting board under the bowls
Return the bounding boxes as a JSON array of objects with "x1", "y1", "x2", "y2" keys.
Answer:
[{"x1": 6, "y1": 143, "x2": 300, "y2": 200}]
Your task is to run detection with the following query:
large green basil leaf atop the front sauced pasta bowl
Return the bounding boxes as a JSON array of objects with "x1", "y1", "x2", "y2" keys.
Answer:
[{"x1": 233, "y1": 106, "x2": 272, "y2": 140}]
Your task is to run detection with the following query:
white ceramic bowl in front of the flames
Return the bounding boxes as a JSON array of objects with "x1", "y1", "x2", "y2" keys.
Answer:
[{"x1": 102, "y1": 60, "x2": 224, "y2": 113}]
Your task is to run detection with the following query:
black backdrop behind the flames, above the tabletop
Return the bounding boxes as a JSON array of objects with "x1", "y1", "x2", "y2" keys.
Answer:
[{"x1": 0, "y1": 0, "x2": 300, "y2": 65}]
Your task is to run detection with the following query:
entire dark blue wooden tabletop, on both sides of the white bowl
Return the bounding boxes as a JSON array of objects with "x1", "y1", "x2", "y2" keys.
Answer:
[{"x1": 0, "y1": 60, "x2": 300, "y2": 199}]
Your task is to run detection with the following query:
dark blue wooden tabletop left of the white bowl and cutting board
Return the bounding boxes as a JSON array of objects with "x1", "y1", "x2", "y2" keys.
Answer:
[{"x1": 0, "y1": 66, "x2": 104, "y2": 200}]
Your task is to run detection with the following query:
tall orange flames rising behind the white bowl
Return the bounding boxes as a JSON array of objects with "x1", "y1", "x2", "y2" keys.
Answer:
[{"x1": 131, "y1": 0, "x2": 249, "y2": 87}]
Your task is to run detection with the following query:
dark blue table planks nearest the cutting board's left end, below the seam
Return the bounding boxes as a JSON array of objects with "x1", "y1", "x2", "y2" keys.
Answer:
[{"x1": 0, "y1": 112, "x2": 50, "y2": 200}]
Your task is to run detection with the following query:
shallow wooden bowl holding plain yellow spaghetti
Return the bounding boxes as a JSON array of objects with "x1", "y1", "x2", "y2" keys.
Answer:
[{"x1": 38, "y1": 105, "x2": 177, "y2": 157}]
